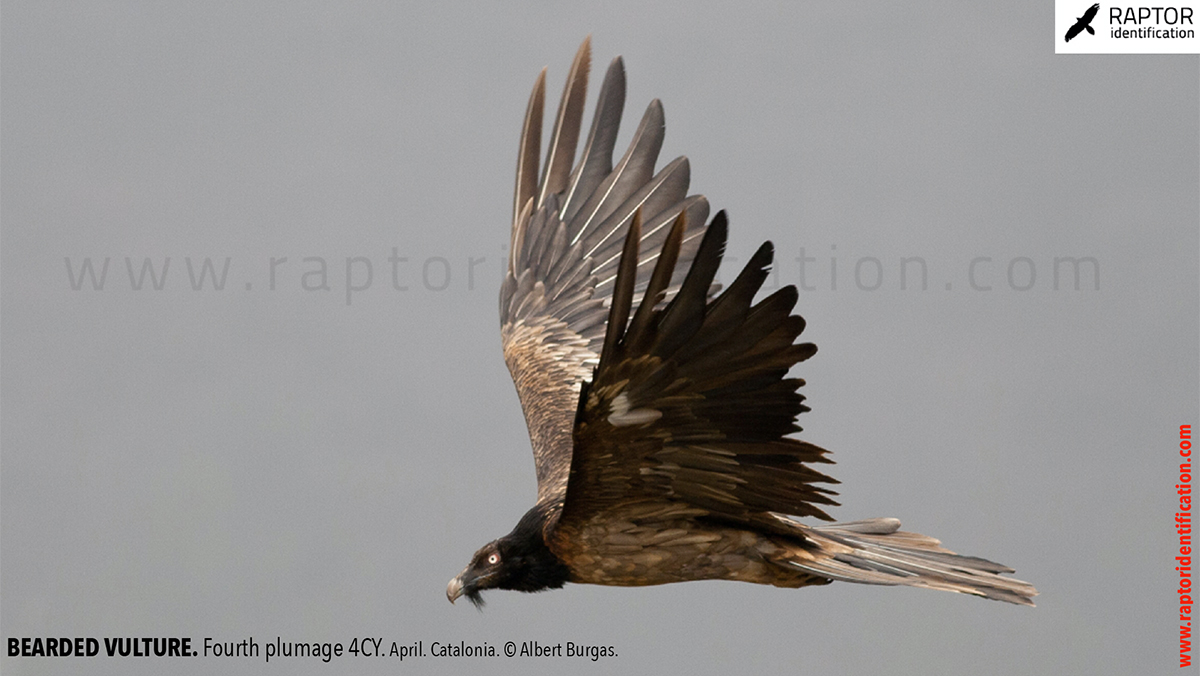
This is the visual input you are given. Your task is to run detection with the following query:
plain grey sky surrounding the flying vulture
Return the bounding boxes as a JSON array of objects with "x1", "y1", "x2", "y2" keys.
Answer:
[{"x1": 0, "y1": 1, "x2": 1200, "y2": 675}]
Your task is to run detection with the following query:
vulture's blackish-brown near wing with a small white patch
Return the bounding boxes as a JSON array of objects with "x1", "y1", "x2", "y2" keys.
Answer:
[{"x1": 560, "y1": 213, "x2": 836, "y2": 533}]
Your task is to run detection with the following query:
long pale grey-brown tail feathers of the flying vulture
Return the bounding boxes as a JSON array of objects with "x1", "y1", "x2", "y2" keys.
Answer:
[{"x1": 786, "y1": 519, "x2": 1038, "y2": 605}]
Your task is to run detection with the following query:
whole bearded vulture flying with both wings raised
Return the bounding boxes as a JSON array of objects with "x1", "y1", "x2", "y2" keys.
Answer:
[{"x1": 446, "y1": 40, "x2": 1037, "y2": 606}]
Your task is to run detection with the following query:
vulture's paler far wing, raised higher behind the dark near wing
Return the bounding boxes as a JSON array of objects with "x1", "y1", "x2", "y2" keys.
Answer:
[{"x1": 500, "y1": 40, "x2": 708, "y2": 504}]
